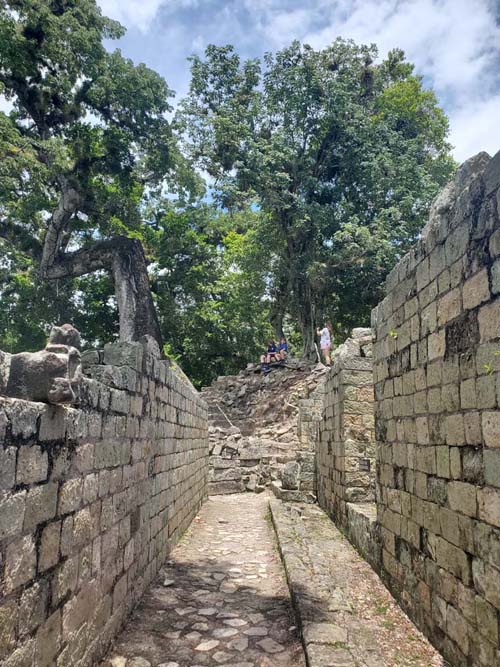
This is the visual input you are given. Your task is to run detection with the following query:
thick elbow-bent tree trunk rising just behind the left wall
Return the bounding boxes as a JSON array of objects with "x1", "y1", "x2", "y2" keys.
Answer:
[{"x1": 41, "y1": 236, "x2": 163, "y2": 350}]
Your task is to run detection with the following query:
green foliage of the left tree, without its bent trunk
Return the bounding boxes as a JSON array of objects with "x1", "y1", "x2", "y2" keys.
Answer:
[{"x1": 0, "y1": 0, "x2": 176, "y2": 351}]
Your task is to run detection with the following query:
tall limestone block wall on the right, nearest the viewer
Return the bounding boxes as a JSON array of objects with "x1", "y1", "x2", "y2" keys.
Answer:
[{"x1": 373, "y1": 153, "x2": 500, "y2": 667}]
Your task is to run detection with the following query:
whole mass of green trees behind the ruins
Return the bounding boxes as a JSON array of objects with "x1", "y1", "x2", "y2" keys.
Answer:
[{"x1": 0, "y1": 0, "x2": 454, "y2": 384}]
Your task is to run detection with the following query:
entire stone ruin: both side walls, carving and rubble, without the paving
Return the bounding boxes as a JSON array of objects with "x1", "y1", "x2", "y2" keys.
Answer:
[{"x1": 0, "y1": 153, "x2": 500, "y2": 667}]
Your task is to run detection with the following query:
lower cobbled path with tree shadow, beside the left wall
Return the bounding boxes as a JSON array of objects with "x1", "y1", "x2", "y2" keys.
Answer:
[{"x1": 101, "y1": 494, "x2": 305, "y2": 667}]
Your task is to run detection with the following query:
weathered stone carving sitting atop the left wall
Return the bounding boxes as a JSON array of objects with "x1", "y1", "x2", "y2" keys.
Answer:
[{"x1": 2, "y1": 324, "x2": 81, "y2": 404}]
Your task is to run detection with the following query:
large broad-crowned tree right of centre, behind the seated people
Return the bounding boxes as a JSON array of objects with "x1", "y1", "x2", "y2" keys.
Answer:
[{"x1": 177, "y1": 39, "x2": 454, "y2": 355}]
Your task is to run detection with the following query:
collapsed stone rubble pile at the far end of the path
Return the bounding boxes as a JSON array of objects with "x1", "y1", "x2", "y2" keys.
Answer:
[{"x1": 202, "y1": 360, "x2": 328, "y2": 495}]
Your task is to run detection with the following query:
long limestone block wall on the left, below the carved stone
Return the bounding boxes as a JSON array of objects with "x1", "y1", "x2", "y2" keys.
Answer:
[{"x1": 0, "y1": 343, "x2": 208, "y2": 667}]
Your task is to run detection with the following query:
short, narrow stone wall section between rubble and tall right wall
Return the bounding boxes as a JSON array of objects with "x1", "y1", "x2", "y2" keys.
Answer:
[{"x1": 316, "y1": 329, "x2": 375, "y2": 527}]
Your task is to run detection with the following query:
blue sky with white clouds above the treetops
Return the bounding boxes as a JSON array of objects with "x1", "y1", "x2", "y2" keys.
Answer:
[{"x1": 97, "y1": 0, "x2": 500, "y2": 162}]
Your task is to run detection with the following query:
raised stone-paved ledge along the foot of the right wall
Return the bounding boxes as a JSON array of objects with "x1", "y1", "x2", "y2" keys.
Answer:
[{"x1": 271, "y1": 500, "x2": 444, "y2": 667}]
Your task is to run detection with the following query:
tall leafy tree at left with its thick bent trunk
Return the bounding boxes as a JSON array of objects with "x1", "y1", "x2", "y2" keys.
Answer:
[{"x1": 0, "y1": 0, "x2": 175, "y2": 350}]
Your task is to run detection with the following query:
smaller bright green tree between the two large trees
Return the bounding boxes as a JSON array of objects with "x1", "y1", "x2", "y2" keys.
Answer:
[{"x1": 155, "y1": 204, "x2": 270, "y2": 386}]
